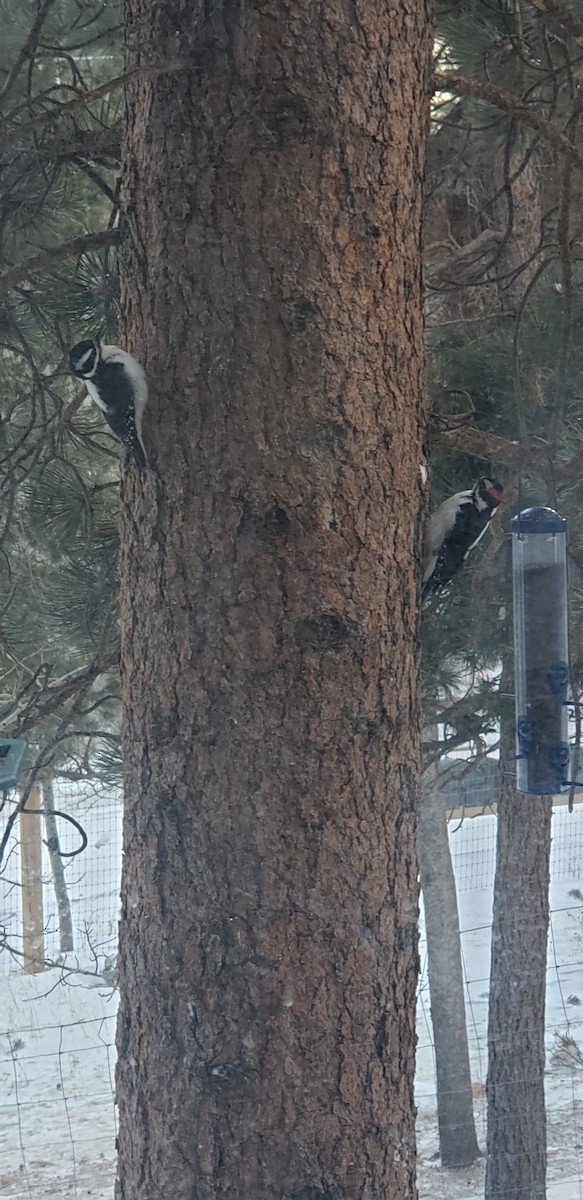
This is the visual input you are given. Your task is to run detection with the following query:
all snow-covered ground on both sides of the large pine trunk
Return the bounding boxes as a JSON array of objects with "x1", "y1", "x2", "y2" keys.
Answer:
[{"x1": 0, "y1": 796, "x2": 583, "y2": 1200}]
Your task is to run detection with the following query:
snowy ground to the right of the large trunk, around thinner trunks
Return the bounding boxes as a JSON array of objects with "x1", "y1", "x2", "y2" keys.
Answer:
[{"x1": 416, "y1": 805, "x2": 583, "y2": 1200}]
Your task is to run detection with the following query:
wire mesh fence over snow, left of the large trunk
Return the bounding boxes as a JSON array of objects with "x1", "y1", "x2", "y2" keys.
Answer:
[{"x1": 0, "y1": 780, "x2": 122, "y2": 1200}]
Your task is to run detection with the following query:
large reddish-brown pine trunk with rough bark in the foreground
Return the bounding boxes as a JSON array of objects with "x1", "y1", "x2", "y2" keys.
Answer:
[{"x1": 116, "y1": 0, "x2": 431, "y2": 1200}]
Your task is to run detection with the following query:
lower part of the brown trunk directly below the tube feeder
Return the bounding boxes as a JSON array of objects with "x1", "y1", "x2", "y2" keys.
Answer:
[{"x1": 486, "y1": 722, "x2": 552, "y2": 1200}]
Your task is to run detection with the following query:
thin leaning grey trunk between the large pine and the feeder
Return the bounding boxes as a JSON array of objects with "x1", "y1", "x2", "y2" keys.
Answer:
[{"x1": 417, "y1": 744, "x2": 480, "y2": 1166}]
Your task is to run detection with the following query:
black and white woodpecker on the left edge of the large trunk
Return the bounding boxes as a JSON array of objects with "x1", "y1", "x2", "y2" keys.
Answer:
[{"x1": 68, "y1": 338, "x2": 148, "y2": 472}]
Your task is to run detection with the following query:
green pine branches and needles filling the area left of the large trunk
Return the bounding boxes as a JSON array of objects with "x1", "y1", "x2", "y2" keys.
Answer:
[{"x1": 0, "y1": 0, "x2": 119, "y2": 816}]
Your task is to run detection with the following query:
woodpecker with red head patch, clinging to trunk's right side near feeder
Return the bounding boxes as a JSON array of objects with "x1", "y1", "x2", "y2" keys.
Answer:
[{"x1": 422, "y1": 476, "x2": 504, "y2": 599}]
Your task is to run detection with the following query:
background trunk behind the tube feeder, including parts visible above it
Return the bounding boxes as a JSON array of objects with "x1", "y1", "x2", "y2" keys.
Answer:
[{"x1": 486, "y1": 129, "x2": 552, "y2": 1200}]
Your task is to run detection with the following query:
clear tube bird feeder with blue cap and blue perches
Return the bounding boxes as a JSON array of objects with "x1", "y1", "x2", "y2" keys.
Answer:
[{"x1": 512, "y1": 508, "x2": 570, "y2": 796}]
